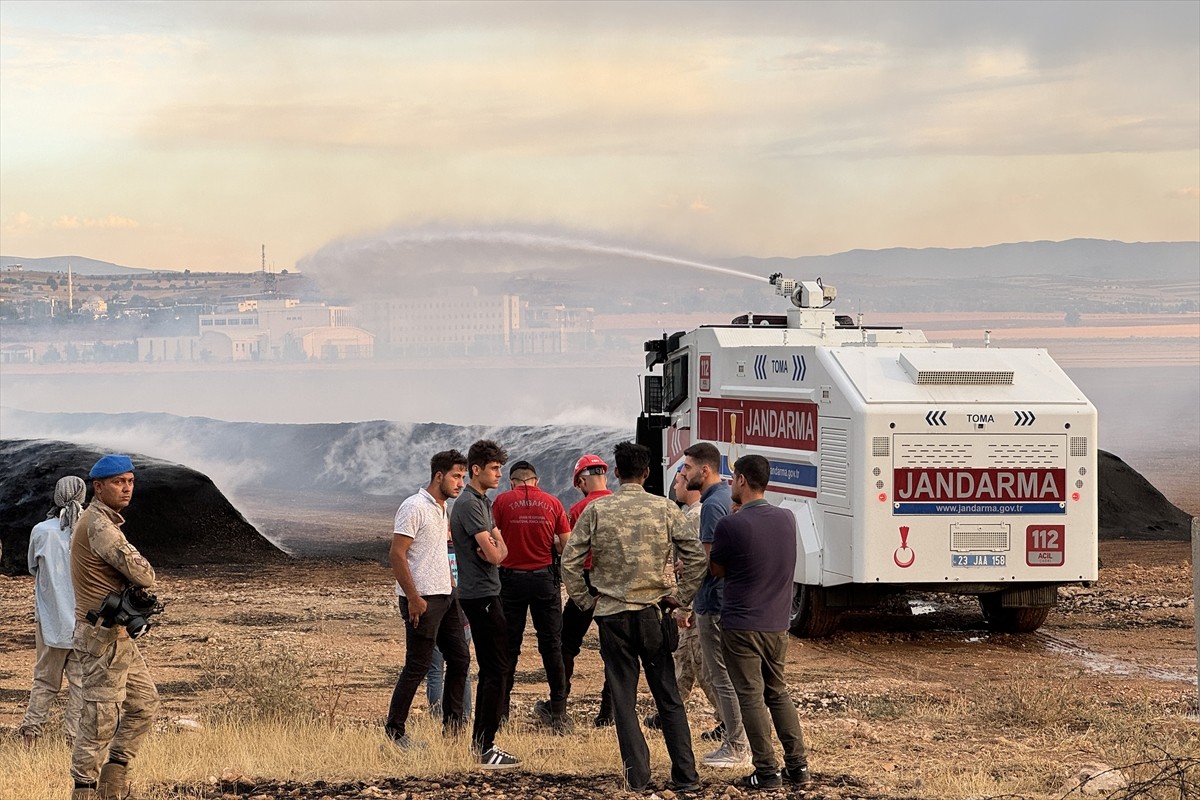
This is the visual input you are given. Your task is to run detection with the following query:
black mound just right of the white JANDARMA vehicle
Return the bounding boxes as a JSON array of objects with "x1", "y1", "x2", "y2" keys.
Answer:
[{"x1": 1097, "y1": 450, "x2": 1192, "y2": 542}]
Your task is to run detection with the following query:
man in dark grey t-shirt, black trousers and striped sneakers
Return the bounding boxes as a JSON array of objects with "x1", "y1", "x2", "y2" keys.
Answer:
[{"x1": 450, "y1": 439, "x2": 521, "y2": 769}]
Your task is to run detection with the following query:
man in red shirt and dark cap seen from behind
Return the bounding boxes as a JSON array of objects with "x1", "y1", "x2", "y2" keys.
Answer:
[{"x1": 492, "y1": 461, "x2": 572, "y2": 733}]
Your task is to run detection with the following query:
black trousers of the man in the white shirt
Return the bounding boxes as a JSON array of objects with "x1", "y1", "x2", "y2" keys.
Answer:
[{"x1": 385, "y1": 594, "x2": 470, "y2": 739}]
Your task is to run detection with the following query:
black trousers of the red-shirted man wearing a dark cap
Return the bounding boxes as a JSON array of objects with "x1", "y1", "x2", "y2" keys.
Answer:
[{"x1": 500, "y1": 567, "x2": 566, "y2": 717}]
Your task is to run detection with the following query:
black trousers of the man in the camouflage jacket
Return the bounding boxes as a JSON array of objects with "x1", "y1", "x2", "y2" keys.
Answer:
[{"x1": 596, "y1": 606, "x2": 700, "y2": 792}]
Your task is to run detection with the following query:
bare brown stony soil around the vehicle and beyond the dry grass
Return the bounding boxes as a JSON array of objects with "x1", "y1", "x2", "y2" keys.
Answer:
[{"x1": 0, "y1": 541, "x2": 1200, "y2": 800}]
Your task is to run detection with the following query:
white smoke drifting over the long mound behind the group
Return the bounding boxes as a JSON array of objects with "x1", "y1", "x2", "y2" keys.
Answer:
[{"x1": 4, "y1": 411, "x2": 632, "y2": 499}]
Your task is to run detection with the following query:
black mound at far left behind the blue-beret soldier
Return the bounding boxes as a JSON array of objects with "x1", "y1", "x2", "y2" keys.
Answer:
[{"x1": 0, "y1": 439, "x2": 287, "y2": 575}]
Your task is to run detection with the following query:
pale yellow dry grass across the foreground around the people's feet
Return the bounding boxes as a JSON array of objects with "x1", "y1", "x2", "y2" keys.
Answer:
[{"x1": 0, "y1": 671, "x2": 1200, "y2": 800}]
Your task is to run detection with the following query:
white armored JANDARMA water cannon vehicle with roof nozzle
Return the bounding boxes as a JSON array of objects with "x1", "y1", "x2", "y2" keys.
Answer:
[{"x1": 637, "y1": 275, "x2": 1098, "y2": 637}]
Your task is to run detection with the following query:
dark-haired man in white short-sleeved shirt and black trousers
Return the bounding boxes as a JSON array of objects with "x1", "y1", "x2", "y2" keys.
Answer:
[{"x1": 384, "y1": 450, "x2": 470, "y2": 750}]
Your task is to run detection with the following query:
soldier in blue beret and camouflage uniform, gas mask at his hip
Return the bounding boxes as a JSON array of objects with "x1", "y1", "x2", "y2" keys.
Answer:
[{"x1": 71, "y1": 456, "x2": 158, "y2": 800}]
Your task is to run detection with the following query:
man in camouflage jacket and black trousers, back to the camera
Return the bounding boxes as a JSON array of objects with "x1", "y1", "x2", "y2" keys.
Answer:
[{"x1": 563, "y1": 441, "x2": 707, "y2": 792}]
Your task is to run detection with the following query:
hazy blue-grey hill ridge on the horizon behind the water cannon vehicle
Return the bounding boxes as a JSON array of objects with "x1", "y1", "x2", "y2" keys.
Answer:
[{"x1": 722, "y1": 239, "x2": 1200, "y2": 281}]
